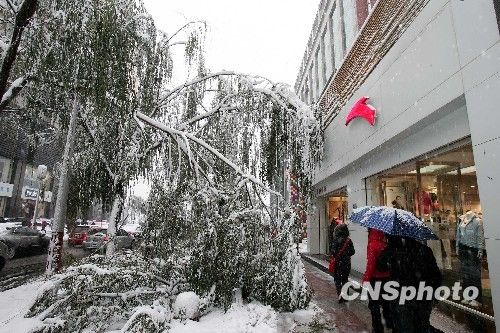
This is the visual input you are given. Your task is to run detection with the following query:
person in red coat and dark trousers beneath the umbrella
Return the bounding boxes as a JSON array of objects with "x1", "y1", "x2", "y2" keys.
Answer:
[{"x1": 363, "y1": 228, "x2": 393, "y2": 333}]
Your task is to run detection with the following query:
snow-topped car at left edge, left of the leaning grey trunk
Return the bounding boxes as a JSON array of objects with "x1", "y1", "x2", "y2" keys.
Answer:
[{"x1": 0, "y1": 227, "x2": 50, "y2": 259}]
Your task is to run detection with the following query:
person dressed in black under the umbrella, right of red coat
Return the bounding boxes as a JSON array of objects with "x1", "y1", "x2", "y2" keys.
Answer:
[{"x1": 377, "y1": 235, "x2": 441, "y2": 333}]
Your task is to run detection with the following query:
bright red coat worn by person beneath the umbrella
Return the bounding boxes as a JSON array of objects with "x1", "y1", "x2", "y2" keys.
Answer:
[{"x1": 363, "y1": 229, "x2": 389, "y2": 282}]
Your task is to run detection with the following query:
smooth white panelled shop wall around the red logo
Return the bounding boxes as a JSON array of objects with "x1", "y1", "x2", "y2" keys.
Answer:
[{"x1": 310, "y1": 0, "x2": 500, "y2": 327}]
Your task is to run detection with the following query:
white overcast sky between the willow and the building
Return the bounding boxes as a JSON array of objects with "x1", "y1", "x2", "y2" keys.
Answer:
[{"x1": 144, "y1": 0, "x2": 319, "y2": 86}]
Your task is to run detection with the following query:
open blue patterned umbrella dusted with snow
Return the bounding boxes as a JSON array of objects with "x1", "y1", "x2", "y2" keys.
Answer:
[{"x1": 349, "y1": 206, "x2": 439, "y2": 240}]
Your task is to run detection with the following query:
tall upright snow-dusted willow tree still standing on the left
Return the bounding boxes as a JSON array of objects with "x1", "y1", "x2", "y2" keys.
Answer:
[{"x1": 12, "y1": 0, "x2": 204, "y2": 272}]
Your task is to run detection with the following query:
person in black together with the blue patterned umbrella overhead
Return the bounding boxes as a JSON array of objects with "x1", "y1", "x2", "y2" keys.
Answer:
[{"x1": 350, "y1": 206, "x2": 441, "y2": 333}]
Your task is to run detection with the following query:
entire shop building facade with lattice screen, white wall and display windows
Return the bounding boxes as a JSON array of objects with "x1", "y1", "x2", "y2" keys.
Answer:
[{"x1": 295, "y1": 0, "x2": 500, "y2": 324}]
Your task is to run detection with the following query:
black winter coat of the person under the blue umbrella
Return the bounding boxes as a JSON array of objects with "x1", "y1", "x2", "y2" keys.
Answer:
[{"x1": 377, "y1": 236, "x2": 441, "y2": 296}]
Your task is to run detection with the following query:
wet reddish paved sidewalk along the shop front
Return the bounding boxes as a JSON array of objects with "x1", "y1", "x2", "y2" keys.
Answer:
[{"x1": 302, "y1": 253, "x2": 495, "y2": 333}]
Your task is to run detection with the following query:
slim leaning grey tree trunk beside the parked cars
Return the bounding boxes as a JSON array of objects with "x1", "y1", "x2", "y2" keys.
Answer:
[{"x1": 46, "y1": 97, "x2": 79, "y2": 275}]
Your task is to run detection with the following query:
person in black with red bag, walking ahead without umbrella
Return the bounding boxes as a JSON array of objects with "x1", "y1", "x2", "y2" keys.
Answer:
[{"x1": 330, "y1": 224, "x2": 355, "y2": 303}]
